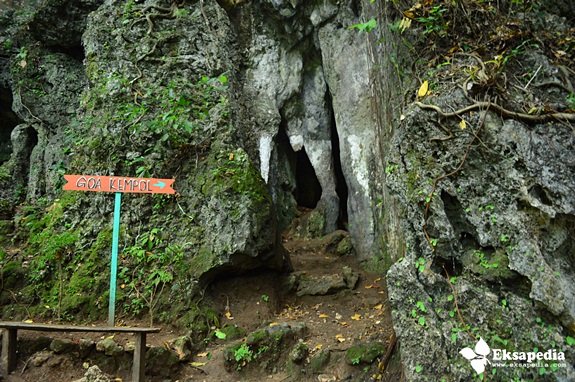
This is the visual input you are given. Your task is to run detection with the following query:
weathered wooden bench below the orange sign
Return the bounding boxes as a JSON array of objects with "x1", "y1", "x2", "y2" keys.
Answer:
[{"x1": 0, "y1": 321, "x2": 161, "y2": 382}]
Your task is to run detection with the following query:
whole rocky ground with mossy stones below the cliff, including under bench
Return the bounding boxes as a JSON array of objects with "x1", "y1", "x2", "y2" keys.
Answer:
[{"x1": 0, "y1": 210, "x2": 401, "y2": 382}]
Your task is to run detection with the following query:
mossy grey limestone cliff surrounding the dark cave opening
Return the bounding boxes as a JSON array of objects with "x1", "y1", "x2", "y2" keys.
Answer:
[{"x1": 0, "y1": 0, "x2": 575, "y2": 381}]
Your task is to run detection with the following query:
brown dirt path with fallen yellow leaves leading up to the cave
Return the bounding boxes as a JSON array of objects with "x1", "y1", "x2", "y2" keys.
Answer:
[{"x1": 180, "y1": 227, "x2": 401, "y2": 381}]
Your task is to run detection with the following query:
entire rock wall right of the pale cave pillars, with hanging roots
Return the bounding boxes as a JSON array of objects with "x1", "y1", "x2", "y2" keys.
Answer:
[{"x1": 373, "y1": 2, "x2": 575, "y2": 381}]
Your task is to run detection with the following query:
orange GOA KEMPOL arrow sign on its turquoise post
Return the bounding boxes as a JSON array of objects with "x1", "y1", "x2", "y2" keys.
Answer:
[{"x1": 62, "y1": 175, "x2": 176, "y2": 326}]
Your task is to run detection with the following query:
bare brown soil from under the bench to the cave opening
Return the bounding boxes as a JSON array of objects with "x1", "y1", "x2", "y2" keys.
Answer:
[{"x1": 0, "y1": 227, "x2": 401, "y2": 382}]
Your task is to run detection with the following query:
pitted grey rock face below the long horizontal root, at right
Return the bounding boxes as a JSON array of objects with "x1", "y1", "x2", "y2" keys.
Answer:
[{"x1": 386, "y1": 47, "x2": 575, "y2": 381}]
